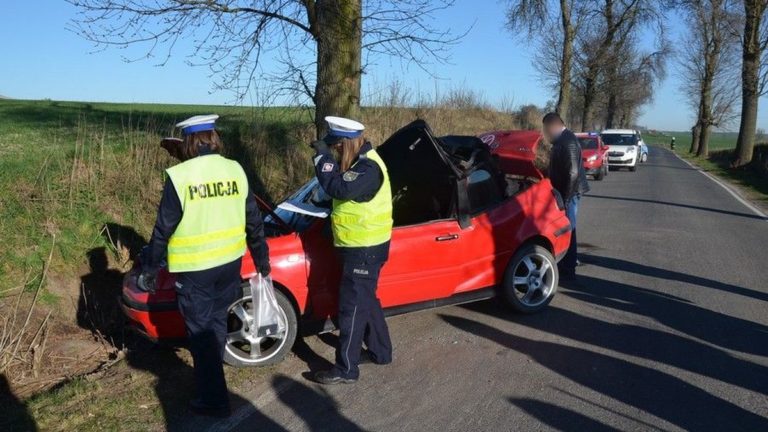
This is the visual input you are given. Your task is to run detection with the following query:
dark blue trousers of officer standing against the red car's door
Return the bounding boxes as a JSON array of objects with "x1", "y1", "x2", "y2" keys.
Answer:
[{"x1": 335, "y1": 255, "x2": 392, "y2": 379}]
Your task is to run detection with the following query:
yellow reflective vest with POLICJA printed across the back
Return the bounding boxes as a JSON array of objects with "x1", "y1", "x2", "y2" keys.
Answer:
[{"x1": 166, "y1": 154, "x2": 248, "y2": 273}]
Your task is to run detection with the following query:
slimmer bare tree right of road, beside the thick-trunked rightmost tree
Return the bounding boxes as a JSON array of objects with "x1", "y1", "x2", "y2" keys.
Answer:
[{"x1": 679, "y1": 0, "x2": 740, "y2": 156}]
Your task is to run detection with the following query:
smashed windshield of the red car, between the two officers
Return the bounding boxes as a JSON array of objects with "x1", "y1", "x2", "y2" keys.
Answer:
[{"x1": 264, "y1": 177, "x2": 331, "y2": 233}]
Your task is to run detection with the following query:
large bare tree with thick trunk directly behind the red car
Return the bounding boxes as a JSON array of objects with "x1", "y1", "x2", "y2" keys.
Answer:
[{"x1": 67, "y1": 0, "x2": 463, "y2": 134}]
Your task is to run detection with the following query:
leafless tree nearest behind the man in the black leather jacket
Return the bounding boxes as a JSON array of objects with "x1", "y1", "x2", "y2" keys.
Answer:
[{"x1": 507, "y1": 0, "x2": 589, "y2": 119}]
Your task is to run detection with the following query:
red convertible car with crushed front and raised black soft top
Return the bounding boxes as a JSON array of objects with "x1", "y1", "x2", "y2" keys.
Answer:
[{"x1": 122, "y1": 121, "x2": 570, "y2": 366}]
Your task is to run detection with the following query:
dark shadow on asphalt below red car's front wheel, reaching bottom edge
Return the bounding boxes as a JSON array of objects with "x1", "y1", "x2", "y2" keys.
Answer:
[{"x1": 272, "y1": 375, "x2": 365, "y2": 432}]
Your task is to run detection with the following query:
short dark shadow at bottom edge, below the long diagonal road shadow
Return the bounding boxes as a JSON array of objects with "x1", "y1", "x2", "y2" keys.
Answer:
[{"x1": 508, "y1": 398, "x2": 618, "y2": 432}]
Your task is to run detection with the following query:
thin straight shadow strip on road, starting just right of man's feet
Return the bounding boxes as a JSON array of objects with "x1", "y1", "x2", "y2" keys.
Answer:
[{"x1": 579, "y1": 254, "x2": 768, "y2": 302}]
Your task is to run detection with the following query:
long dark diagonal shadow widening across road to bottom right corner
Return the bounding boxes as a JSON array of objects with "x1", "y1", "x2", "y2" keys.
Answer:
[{"x1": 440, "y1": 314, "x2": 768, "y2": 431}]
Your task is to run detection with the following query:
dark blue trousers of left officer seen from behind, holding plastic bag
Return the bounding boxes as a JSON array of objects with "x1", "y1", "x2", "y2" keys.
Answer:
[{"x1": 176, "y1": 259, "x2": 241, "y2": 408}]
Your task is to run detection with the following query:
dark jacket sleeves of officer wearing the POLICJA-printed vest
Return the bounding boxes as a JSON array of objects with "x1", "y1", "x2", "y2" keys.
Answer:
[{"x1": 142, "y1": 155, "x2": 272, "y2": 276}]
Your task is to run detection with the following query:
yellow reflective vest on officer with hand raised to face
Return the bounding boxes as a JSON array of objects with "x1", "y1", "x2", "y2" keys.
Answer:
[{"x1": 331, "y1": 150, "x2": 392, "y2": 247}]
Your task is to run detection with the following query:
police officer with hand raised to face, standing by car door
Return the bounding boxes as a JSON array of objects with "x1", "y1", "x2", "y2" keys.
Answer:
[{"x1": 312, "y1": 117, "x2": 392, "y2": 384}]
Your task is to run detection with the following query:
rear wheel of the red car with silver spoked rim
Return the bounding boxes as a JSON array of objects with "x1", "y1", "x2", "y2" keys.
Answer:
[{"x1": 502, "y1": 244, "x2": 558, "y2": 314}]
